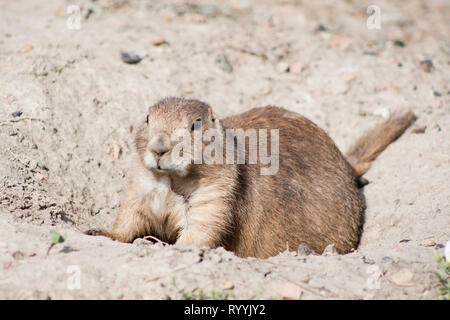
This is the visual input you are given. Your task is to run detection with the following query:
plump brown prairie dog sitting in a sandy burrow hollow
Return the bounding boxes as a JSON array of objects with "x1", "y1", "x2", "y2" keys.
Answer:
[{"x1": 89, "y1": 97, "x2": 414, "y2": 258}]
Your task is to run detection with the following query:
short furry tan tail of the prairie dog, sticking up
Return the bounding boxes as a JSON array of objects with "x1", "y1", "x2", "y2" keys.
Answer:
[{"x1": 345, "y1": 110, "x2": 415, "y2": 178}]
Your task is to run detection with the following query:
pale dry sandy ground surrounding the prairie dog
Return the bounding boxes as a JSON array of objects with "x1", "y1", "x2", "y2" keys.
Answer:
[{"x1": 0, "y1": 0, "x2": 450, "y2": 299}]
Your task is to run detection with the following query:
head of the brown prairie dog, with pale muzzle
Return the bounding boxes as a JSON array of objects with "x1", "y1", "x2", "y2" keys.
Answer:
[{"x1": 136, "y1": 98, "x2": 222, "y2": 176}]
